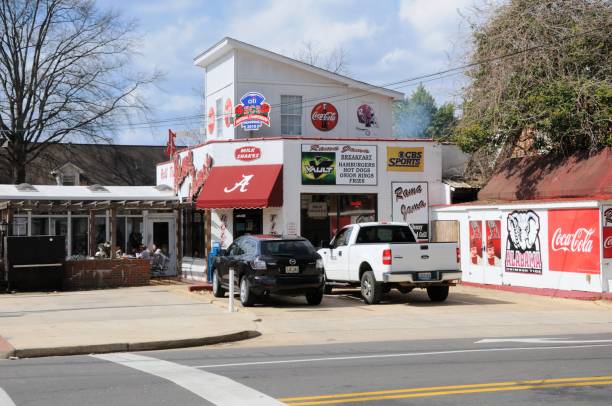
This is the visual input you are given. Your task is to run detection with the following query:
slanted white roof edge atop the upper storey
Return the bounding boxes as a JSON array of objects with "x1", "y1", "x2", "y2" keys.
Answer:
[{"x1": 194, "y1": 37, "x2": 404, "y2": 100}]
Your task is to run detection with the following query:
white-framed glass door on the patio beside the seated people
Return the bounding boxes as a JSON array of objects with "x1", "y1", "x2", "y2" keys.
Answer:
[{"x1": 147, "y1": 217, "x2": 177, "y2": 276}]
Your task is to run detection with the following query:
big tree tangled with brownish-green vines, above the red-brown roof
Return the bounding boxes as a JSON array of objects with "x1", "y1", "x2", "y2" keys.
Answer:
[{"x1": 454, "y1": 0, "x2": 612, "y2": 154}]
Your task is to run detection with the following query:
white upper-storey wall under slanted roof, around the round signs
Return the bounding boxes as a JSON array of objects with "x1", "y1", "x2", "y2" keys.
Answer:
[{"x1": 205, "y1": 50, "x2": 392, "y2": 140}]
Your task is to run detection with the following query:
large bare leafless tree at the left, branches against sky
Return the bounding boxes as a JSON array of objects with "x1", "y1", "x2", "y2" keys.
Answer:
[{"x1": 0, "y1": 0, "x2": 158, "y2": 183}]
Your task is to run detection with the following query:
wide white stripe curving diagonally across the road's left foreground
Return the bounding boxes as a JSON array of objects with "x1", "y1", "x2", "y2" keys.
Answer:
[{"x1": 92, "y1": 353, "x2": 284, "y2": 406}]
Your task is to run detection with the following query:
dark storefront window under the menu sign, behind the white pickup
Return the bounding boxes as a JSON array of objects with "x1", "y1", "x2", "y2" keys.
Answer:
[{"x1": 301, "y1": 194, "x2": 378, "y2": 247}]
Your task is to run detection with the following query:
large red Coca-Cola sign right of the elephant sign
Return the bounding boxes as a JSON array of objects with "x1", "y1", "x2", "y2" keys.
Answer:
[{"x1": 548, "y1": 209, "x2": 599, "y2": 273}]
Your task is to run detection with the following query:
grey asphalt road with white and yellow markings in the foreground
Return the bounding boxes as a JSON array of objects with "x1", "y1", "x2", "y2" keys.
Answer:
[{"x1": 0, "y1": 334, "x2": 612, "y2": 406}]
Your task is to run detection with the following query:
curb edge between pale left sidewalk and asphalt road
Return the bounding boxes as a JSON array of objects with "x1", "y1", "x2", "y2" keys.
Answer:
[{"x1": 5, "y1": 330, "x2": 261, "y2": 359}]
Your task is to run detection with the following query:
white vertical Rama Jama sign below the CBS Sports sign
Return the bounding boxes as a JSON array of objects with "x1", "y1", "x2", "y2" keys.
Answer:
[{"x1": 391, "y1": 182, "x2": 429, "y2": 241}]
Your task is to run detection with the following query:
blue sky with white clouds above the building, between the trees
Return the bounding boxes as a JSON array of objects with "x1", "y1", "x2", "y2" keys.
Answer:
[{"x1": 103, "y1": 0, "x2": 476, "y2": 144}]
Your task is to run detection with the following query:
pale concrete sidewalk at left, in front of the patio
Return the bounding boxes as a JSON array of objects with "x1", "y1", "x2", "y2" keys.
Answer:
[{"x1": 0, "y1": 285, "x2": 258, "y2": 358}]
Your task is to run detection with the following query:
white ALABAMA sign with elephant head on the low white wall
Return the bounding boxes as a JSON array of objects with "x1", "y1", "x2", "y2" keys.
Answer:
[{"x1": 505, "y1": 210, "x2": 542, "y2": 275}]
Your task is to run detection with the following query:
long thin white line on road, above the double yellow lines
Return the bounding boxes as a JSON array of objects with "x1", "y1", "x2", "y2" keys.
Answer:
[{"x1": 193, "y1": 344, "x2": 612, "y2": 369}]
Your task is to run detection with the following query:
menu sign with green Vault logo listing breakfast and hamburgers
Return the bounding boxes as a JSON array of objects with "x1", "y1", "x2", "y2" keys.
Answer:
[{"x1": 301, "y1": 144, "x2": 377, "y2": 186}]
